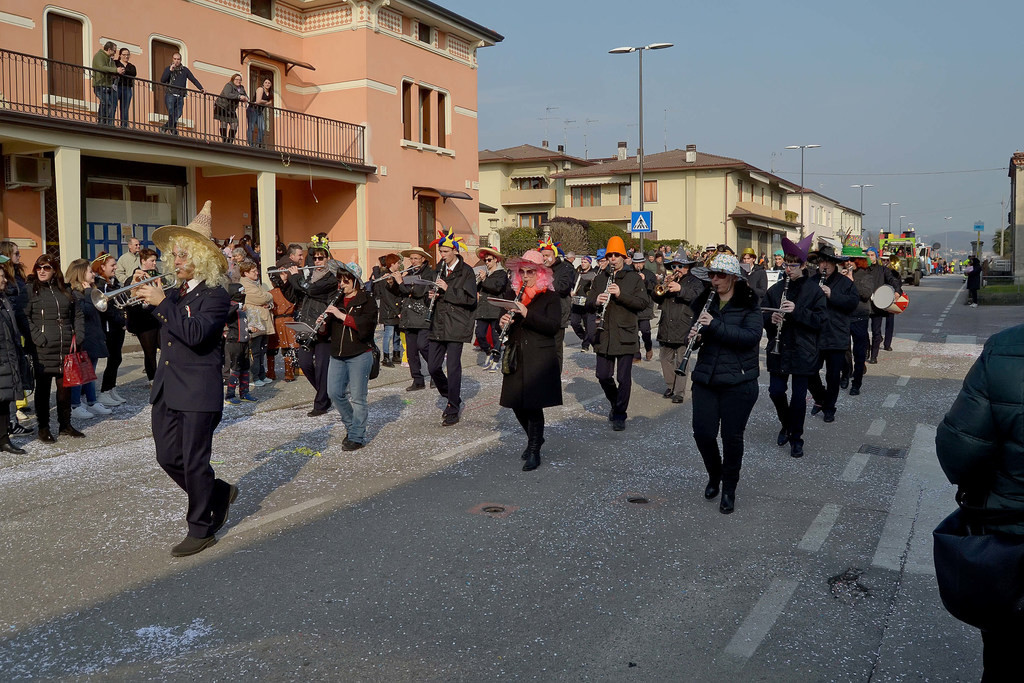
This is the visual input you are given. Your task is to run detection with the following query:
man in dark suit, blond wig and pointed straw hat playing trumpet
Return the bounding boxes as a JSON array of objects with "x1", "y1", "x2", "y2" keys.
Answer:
[{"x1": 138, "y1": 202, "x2": 239, "y2": 557}]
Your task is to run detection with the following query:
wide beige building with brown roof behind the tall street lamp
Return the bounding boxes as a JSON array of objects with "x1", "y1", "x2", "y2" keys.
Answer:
[{"x1": 555, "y1": 142, "x2": 799, "y2": 259}]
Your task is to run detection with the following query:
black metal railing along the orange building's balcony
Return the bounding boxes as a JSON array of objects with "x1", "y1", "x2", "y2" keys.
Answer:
[{"x1": 0, "y1": 49, "x2": 366, "y2": 165}]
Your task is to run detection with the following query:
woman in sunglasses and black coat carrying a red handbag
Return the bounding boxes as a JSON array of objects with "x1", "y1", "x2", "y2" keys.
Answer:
[{"x1": 25, "y1": 254, "x2": 85, "y2": 443}]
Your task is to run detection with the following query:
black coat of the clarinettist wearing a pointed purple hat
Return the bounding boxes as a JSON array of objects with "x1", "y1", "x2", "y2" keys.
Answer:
[{"x1": 763, "y1": 275, "x2": 828, "y2": 375}]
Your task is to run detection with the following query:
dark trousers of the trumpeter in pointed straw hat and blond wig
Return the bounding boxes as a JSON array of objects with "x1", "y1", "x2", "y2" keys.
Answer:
[{"x1": 153, "y1": 391, "x2": 223, "y2": 539}]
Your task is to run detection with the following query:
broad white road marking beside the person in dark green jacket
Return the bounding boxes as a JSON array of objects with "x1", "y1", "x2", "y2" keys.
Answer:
[{"x1": 871, "y1": 424, "x2": 955, "y2": 574}]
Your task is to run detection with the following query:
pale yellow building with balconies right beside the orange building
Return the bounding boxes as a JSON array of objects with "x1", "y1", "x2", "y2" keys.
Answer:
[{"x1": 479, "y1": 140, "x2": 594, "y2": 238}]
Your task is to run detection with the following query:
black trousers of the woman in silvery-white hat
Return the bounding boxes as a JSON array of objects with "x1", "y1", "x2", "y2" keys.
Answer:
[{"x1": 691, "y1": 380, "x2": 758, "y2": 493}]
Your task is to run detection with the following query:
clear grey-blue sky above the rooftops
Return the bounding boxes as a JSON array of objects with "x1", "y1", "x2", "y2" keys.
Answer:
[{"x1": 440, "y1": 0, "x2": 1024, "y2": 255}]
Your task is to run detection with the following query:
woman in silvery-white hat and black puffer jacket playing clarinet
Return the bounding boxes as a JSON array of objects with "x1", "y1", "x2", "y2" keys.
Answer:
[{"x1": 690, "y1": 254, "x2": 761, "y2": 514}]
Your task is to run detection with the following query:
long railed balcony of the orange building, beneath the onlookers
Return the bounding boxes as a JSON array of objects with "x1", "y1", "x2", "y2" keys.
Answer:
[{"x1": 0, "y1": 49, "x2": 373, "y2": 172}]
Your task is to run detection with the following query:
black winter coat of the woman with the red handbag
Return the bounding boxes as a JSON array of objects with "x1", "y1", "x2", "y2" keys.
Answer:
[{"x1": 25, "y1": 279, "x2": 85, "y2": 375}]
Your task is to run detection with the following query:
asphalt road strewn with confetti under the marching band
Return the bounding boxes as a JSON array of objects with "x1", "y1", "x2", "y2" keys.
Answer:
[{"x1": 0, "y1": 276, "x2": 1024, "y2": 681}]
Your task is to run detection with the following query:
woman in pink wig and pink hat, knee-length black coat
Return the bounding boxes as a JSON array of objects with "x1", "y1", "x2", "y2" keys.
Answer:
[{"x1": 499, "y1": 250, "x2": 562, "y2": 472}]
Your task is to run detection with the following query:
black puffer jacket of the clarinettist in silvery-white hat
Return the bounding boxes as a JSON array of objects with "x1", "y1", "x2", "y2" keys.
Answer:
[{"x1": 690, "y1": 282, "x2": 762, "y2": 386}]
